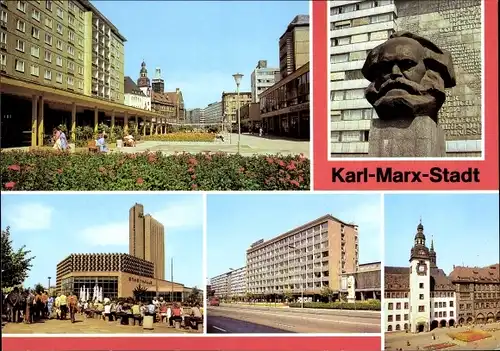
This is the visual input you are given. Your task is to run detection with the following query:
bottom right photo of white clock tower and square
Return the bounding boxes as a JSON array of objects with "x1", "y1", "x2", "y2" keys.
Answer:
[{"x1": 383, "y1": 192, "x2": 500, "y2": 350}]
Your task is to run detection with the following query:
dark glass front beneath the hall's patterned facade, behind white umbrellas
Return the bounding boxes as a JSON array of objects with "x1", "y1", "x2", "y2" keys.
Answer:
[{"x1": 61, "y1": 277, "x2": 118, "y2": 300}]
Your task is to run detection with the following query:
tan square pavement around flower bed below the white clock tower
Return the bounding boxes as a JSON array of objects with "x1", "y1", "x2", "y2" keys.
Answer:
[{"x1": 385, "y1": 323, "x2": 500, "y2": 351}]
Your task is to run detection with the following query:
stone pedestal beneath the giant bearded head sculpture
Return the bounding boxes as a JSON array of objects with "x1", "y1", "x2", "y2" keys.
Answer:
[{"x1": 368, "y1": 116, "x2": 446, "y2": 158}]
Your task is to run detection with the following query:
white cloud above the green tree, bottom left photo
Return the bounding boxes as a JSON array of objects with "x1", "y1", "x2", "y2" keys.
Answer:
[{"x1": 4, "y1": 203, "x2": 54, "y2": 230}]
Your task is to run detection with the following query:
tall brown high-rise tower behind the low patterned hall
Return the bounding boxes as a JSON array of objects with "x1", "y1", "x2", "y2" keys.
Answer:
[{"x1": 129, "y1": 204, "x2": 165, "y2": 279}]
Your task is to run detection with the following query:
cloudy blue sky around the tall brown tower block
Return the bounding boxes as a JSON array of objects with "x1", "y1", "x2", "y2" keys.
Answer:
[{"x1": 1, "y1": 193, "x2": 204, "y2": 288}]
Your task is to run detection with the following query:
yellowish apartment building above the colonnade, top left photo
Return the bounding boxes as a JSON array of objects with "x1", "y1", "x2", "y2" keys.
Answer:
[{"x1": 0, "y1": 0, "x2": 125, "y2": 104}]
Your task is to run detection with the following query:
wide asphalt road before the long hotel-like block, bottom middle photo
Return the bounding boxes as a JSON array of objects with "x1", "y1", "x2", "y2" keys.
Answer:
[{"x1": 207, "y1": 306, "x2": 380, "y2": 333}]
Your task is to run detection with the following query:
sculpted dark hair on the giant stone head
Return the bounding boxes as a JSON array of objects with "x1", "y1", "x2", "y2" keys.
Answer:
[{"x1": 361, "y1": 31, "x2": 456, "y2": 88}]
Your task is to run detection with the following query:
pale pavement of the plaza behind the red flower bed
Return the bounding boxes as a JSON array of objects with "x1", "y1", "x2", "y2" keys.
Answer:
[{"x1": 120, "y1": 134, "x2": 309, "y2": 157}]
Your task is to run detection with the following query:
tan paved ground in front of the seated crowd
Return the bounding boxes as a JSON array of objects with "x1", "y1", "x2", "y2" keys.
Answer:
[{"x1": 2, "y1": 315, "x2": 199, "y2": 334}]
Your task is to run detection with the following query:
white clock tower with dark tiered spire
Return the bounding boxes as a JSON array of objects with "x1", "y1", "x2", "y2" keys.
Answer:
[{"x1": 409, "y1": 222, "x2": 431, "y2": 333}]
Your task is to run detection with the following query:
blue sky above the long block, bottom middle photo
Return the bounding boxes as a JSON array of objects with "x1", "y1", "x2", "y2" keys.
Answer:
[{"x1": 207, "y1": 193, "x2": 382, "y2": 278}]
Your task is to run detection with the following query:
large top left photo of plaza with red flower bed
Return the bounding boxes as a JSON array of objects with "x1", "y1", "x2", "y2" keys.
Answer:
[{"x1": 0, "y1": 0, "x2": 311, "y2": 191}]
